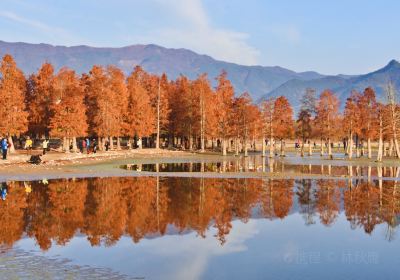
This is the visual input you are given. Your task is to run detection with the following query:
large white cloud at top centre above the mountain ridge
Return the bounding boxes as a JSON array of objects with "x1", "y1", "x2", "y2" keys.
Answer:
[{"x1": 137, "y1": 0, "x2": 260, "y2": 65}]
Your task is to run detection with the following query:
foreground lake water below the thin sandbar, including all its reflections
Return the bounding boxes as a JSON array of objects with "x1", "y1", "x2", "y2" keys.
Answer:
[{"x1": 0, "y1": 177, "x2": 400, "y2": 279}]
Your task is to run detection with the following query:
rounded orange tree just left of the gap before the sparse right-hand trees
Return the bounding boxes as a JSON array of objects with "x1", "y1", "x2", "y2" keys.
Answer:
[{"x1": 273, "y1": 96, "x2": 294, "y2": 156}]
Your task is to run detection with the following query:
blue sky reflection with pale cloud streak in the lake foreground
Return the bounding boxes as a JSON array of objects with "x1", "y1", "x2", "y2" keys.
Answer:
[{"x1": 16, "y1": 213, "x2": 400, "y2": 279}]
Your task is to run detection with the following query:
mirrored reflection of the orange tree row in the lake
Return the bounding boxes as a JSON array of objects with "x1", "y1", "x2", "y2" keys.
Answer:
[{"x1": 0, "y1": 177, "x2": 400, "y2": 250}]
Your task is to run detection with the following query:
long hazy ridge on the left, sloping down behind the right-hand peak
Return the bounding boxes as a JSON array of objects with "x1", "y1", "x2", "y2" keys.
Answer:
[{"x1": 0, "y1": 38, "x2": 323, "y2": 100}]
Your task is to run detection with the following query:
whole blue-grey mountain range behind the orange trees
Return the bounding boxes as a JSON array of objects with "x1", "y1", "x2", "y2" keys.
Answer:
[{"x1": 0, "y1": 41, "x2": 400, "y2": 111}]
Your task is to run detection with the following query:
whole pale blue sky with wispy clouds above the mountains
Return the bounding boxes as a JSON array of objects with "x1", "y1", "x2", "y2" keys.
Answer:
[{"x1": 0, "y1": 0, "x2": 400, "y2": 74}]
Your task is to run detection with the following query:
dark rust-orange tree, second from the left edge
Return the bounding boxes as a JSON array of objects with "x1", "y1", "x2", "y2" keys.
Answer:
[{"x1": 26, "y1": 63, "x2": 54, "y2": 137}]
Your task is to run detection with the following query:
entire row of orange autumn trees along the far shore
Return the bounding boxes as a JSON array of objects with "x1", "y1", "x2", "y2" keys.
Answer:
[{"x1": 0, "y1": 55, "x2": 400, "y2": 160}]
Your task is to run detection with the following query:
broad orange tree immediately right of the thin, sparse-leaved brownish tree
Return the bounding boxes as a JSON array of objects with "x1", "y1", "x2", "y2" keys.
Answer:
[{"x1": 316, "y1": 90, "x2": 340, "y2": 158}]
